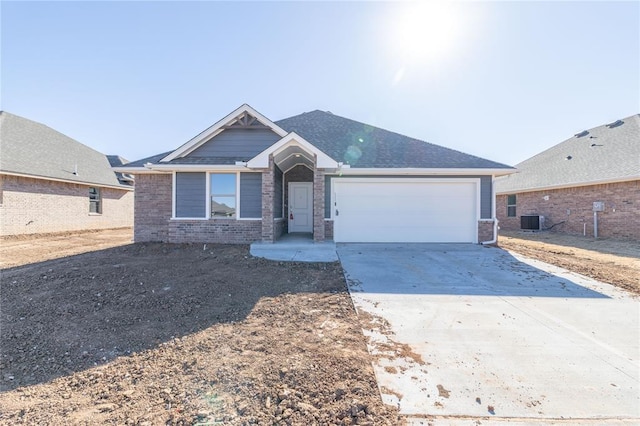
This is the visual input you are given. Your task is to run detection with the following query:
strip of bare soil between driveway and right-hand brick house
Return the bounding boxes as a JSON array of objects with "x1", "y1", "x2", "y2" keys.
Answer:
[{"x1": 498, "y1": 231, "x2": 640, "y2": 295}]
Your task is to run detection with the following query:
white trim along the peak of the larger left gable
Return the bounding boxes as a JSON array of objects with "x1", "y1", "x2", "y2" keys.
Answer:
[{"x1": 160, "y1": 104, "x2": 287, "y2": 163}]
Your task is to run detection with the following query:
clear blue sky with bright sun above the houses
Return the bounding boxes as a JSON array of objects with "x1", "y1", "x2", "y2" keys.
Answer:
[{"x1": 0, "y1": 0, "x2": 640, "y2": 165}]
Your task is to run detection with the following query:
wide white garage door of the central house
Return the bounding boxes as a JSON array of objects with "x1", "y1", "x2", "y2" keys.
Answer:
[{"x1": 332, "y1": 178, "x2": 480, "y2": 243}]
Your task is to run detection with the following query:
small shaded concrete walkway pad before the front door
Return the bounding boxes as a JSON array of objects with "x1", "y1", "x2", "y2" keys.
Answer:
[{"x1": 250, "y1": 234, "x2": 338, "y2": 262}]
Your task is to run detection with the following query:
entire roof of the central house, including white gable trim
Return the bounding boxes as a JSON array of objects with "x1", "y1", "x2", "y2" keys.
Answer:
[{"x1": 118, "y1": 104, "x2": 514, "y2": 174}]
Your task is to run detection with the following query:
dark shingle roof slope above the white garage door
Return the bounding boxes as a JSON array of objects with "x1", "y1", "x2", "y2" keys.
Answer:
[{"x1": 275, "y1": 110, "x2": 510, "y2": 169}]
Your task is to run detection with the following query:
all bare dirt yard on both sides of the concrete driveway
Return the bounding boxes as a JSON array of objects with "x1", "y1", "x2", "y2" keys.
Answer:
[{"x1": 0, "y1": 230, "x2": 640, "y2": 425}]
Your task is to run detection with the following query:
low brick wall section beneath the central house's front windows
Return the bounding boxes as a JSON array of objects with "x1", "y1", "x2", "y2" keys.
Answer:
[{"x1": 168, "y1": 219, "x2": 262, "y2": 244}]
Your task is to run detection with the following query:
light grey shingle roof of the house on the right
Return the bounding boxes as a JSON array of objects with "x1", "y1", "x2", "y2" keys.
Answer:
[{"x1": 496, "y1": 114, "x2": 640, "y2": 194}]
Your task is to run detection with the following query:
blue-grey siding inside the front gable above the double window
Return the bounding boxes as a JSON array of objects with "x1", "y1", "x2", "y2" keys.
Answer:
[{"x1": 188, "y1": 129, "x2": 280, "y2": 160}]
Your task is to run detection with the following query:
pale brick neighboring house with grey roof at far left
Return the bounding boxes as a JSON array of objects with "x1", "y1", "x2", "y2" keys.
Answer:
[{"x1": 0, "y1": 111, "x2": 134, "y2": 236}]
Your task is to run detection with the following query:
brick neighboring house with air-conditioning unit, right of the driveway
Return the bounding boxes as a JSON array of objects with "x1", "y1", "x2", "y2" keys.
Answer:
[{"x1": 496, "y1": 114, "x2": 640, "y2": 240}]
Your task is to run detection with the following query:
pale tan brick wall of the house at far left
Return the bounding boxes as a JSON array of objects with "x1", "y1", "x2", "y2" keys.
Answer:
[{"x1": 0, "y1": 175, "x2": 134, "y2": 236}]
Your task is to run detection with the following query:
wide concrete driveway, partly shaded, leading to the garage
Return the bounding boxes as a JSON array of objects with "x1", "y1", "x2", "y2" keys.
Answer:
[{"x1": 337, "y1": 244, "x2": 640, "y2": 424}]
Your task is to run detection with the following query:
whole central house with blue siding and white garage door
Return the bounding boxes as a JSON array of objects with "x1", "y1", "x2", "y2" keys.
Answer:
[{"x1": 116, "y1": 104, "x2": 514, "y2": 243}]
